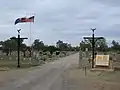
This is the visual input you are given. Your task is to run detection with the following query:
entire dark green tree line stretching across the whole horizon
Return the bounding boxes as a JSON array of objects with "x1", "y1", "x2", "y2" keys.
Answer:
[{"x1": 0, "y1": 37, "x2": 120, "y2": 55}]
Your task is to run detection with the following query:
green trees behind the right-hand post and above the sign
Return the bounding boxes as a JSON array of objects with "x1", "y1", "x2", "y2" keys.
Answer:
[{"x1": 80, "y1": 38, "x2": 120, "y2": 52}]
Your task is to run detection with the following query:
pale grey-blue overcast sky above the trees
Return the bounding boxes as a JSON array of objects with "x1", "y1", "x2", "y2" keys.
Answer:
[{"x1": 0, "y1": 0, "x2": 120, "y2": 45}]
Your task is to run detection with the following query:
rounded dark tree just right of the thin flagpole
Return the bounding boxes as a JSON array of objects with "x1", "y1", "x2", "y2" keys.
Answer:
[{"x1": 32, "y1": 39, "x2": 44, "y2": 51}]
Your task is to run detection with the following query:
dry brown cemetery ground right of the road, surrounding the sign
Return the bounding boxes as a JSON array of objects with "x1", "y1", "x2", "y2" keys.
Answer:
[{"x1": 61, "y1": 52, "x2": 120, "y2": 90}]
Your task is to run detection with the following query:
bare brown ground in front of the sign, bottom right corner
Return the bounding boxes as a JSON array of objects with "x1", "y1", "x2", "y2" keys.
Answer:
[{"x1": 63, "y1": 68, "x2": 120, "y2": 90}]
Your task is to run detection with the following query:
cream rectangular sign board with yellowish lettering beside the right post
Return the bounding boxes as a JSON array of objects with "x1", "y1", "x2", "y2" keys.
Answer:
[{"x1": 95, "y1": 55, "x2": 109, "y2": 66}]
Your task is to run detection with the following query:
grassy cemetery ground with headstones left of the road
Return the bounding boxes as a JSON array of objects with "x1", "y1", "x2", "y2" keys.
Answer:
[{"x1": 0, "y1": 51, "x2": 75, "y2": 71}]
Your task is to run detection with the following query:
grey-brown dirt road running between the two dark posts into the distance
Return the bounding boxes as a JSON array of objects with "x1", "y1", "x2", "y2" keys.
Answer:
[{"x1": 0, "y1": 53, "x2": 79, "y2": 90}]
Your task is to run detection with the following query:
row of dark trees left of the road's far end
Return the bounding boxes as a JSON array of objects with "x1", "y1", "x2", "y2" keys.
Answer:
[{"x1": 0, "y1": 37, "x2": 79, "y2": 55}]
